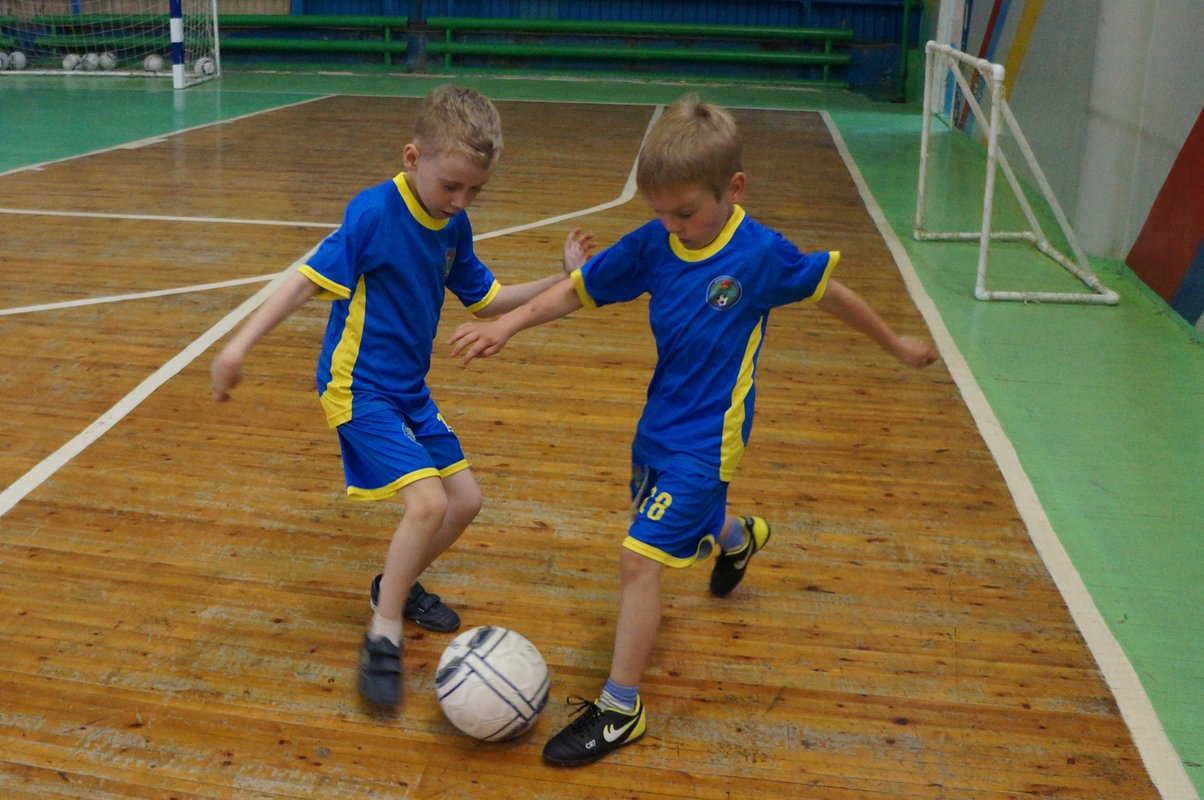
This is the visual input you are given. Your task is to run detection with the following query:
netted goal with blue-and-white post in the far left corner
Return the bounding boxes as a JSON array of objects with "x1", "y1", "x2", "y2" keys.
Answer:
[{"x1": 0, "y1": 0, "x2": 222, "y2": 89}]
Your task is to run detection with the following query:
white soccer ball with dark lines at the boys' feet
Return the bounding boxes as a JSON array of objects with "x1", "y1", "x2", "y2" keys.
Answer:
[{"x1": 435, "y1": 625, "x2": 548, "y2": 742}]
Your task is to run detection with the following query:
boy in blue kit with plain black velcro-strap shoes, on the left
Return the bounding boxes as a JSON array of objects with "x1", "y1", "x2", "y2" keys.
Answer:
[{"x1": 211, "y1": 86, "x2": 591, "y2": 708}]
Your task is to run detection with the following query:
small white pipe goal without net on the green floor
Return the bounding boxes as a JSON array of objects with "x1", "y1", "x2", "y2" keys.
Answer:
[{"x1": 914, "y1": 42, "x2": 1120, "y2": 305}]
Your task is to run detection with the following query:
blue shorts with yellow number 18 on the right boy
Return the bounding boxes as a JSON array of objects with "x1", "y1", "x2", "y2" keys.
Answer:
[{"x1": 622, "y1": 464, "x2": 727, "y2": 566}]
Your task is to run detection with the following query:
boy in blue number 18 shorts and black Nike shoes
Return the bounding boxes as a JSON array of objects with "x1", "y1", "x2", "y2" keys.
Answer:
[{"x1": 450, "y1": 96, "x2": 937, "y2": 766}]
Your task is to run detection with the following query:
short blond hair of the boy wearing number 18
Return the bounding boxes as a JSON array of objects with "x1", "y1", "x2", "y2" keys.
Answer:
[{"x1": 636, "y1": 94, "x2": 744, "y2": 200}]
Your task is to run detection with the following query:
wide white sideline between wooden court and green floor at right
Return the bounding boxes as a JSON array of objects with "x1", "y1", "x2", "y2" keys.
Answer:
[{"x1": 820, "y1": 111, "x2": 1198, "y2": 800}]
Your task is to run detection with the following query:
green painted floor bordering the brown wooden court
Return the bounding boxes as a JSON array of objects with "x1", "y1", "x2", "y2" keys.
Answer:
[{"x1": 0, "y1": 71, "x2": 1204, "y2": 798}]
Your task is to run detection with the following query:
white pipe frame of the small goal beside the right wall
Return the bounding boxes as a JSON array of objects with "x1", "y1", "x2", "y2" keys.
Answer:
[{"x1": 914, "y1": 41, "x2": 1120, "y2": 305}]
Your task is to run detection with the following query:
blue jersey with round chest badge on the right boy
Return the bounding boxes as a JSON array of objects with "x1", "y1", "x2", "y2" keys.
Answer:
[{"x1": 573, "y1": 206, "x2": 840, "y2": 482}]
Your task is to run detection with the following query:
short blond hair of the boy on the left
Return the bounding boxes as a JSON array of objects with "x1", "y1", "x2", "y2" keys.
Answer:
[{"x1": 414, "y1": 84, "x2": 502, "y2": 170}]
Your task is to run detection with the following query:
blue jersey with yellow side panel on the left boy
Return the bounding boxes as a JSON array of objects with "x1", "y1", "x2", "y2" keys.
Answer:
[{"x1": 300, "y1": 173, "x2": 500, "y2": 428}]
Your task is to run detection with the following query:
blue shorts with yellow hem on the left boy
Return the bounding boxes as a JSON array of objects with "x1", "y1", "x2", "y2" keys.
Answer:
[{"x1": 335, "y1": 396, "x2": 468, "y2": 500}]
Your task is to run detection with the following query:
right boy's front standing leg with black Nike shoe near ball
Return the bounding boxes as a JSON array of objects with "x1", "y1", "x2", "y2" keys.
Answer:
[{"x1": 543, "y1": 547, "x2": 665, "y2": 766}]
